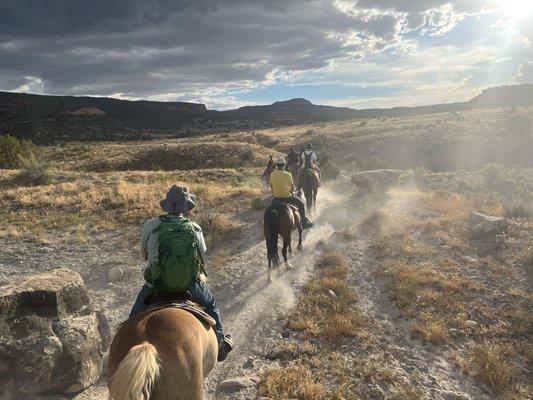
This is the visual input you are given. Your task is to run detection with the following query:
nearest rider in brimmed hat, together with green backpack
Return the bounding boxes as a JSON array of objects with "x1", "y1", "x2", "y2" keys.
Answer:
[{"x1": 130, "y1": 185, "x2": 233, "y2": 361}]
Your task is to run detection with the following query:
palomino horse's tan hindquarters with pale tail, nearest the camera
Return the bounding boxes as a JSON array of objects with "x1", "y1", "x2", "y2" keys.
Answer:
[{"x1": 107, "y1": 308, "x2": 218, "y2": 400}]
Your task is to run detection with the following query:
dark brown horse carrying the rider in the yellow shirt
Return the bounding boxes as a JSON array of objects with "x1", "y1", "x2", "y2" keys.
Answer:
[{"x1": 263, "y1": 202, "x2": 302, "y2": 281}]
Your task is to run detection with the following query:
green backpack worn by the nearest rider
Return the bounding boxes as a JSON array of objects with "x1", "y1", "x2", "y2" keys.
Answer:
[{"x1": 144, "y1": 216, "x2": 203, "y2": 292}]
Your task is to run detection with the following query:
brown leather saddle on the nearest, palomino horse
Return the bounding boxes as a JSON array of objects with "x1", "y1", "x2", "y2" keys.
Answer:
[{"x1": 144, "y1": 292, "x2": 216, "y2": 326}]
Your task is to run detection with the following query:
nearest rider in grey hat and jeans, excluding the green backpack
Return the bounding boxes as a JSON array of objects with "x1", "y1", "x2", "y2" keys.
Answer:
[{"x1": 129, "y1": 185, "x2": 233, "y2": 361}]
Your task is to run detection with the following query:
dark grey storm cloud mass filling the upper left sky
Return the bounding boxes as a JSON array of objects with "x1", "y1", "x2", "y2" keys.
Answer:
[{"x1": 0, "y1": 0, "x2": 516, "y2": 103}]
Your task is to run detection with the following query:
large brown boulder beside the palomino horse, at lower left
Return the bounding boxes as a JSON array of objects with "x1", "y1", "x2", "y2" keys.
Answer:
[{"x1": 0, "y1": 268, "x2": 108, "y2": 398}]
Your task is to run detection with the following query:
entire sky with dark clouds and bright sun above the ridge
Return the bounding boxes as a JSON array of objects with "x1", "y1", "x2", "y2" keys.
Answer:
[{"x1": 0, "y1": 0, "x2": 533, "y2": 110}]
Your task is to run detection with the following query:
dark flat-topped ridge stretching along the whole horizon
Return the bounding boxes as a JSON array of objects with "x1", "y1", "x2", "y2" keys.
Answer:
[{"x1": 0, "y1": 85, "x2": 533, "y2": 144}]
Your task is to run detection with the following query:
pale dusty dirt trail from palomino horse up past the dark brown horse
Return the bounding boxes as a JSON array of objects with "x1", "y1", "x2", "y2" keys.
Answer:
[{"x1": 206, "y1": 186, "x2": 341, "y2": 399}]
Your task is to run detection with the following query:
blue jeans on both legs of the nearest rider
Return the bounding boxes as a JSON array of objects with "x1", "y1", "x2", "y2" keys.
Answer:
[{"x1": 129, "y1": 281, "x2": 224, "y2": 342}]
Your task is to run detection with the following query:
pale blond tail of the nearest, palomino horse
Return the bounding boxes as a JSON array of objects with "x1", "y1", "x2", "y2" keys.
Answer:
[{"x1": 109, "y1": 342, "x2": 161, "y2": 400}]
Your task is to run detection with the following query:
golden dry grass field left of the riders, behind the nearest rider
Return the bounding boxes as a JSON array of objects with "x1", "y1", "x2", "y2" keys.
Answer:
[{"x1": 0, "y1": 170, "x2": 261, "y2": 243}]
